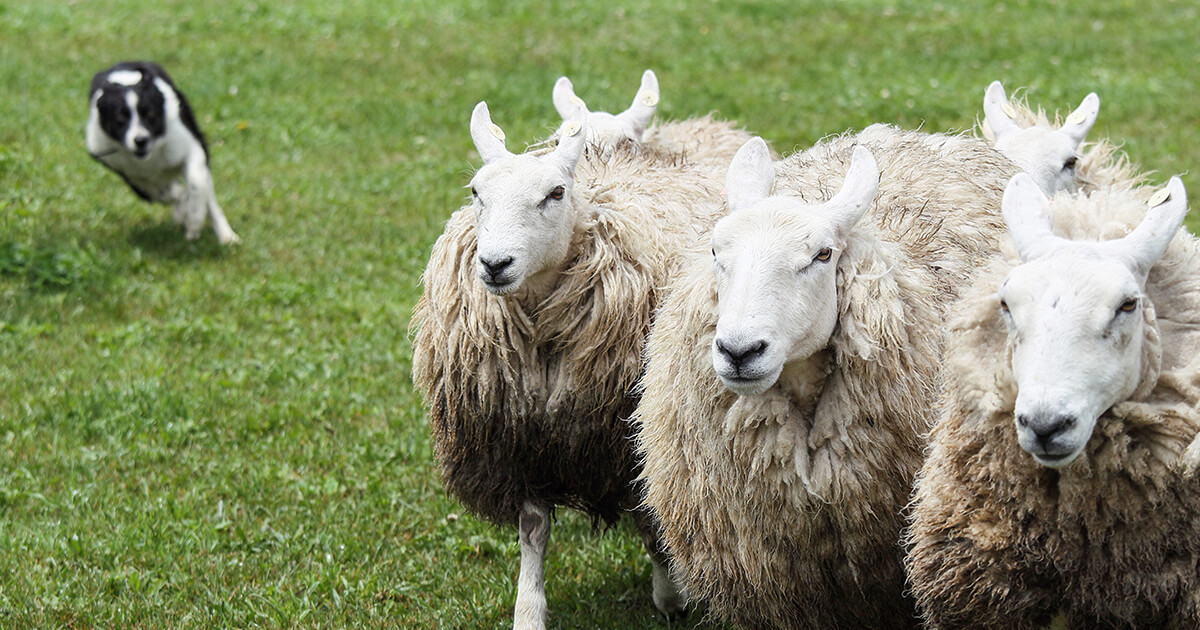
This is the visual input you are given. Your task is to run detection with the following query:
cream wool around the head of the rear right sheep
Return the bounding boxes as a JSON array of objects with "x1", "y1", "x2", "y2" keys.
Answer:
[{"x1": 976, "y1": 94, "x2": 1147, "y2": 194}]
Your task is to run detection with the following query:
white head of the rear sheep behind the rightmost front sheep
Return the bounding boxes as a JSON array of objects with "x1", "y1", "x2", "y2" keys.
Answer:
[{"x1": 983, "y1": 80, "x2": 1100, "y2": 196}]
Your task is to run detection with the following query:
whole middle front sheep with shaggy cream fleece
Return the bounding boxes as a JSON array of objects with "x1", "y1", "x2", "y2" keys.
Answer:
[{"x1": 634, "y1": 125, "x2": 1016, "y2": 629}]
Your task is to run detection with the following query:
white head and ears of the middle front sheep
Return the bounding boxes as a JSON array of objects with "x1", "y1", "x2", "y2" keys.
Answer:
[{"x1": 712, "y1": 138, "x2": 880, "y2": 396}]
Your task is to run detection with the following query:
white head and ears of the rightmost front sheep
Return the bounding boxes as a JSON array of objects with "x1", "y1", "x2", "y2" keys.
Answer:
[{"x1": 1000, "y1": 175, "x2": 1187, "y2": 467}]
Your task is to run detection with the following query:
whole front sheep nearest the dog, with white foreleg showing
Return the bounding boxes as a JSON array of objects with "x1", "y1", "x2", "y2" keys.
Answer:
[{"x1": 413, "y1": 103, "x2": 748, "y2": 628}]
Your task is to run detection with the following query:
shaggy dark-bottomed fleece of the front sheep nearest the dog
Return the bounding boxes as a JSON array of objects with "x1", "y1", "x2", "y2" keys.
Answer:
[{"x1": 413, "y1": 137, "x2": 732, "y2": 524}]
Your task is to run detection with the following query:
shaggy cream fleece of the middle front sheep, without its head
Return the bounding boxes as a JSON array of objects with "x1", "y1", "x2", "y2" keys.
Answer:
[{"x1": 635, "y1": 126, "x2": 1016, "y2": 629}]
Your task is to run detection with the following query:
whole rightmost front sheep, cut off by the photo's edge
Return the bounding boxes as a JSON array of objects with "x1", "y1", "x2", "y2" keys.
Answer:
[{"x1": 907, "y1": 175, "x2": 1200, "y2": 629}]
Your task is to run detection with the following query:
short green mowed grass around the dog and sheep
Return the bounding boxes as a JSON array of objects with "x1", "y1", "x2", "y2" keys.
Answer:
[{"x1": 0, "y1": 0, "x2": 1200, "y2": 629}]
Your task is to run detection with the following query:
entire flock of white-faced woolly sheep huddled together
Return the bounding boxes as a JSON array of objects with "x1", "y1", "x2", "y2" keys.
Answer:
[{"x1": 413, "y1": 71, "x2": 1200, "y2": 629}]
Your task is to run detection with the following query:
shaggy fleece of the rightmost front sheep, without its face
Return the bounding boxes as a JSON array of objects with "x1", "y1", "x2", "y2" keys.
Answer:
[{"x1": 908, "y1": 191, "x2": 1200, "y2": 629}]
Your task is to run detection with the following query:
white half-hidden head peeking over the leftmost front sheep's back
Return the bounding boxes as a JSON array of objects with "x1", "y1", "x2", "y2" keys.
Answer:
[{"x1": 553, "y1": 70, "x2": 659, "y2": 146}]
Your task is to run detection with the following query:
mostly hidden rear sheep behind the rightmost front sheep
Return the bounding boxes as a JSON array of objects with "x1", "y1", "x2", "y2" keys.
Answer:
[{"x1": 979, "y1": 80, "x2": 1142, "y2": 194}]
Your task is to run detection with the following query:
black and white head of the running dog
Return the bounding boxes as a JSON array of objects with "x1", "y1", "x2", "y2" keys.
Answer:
[{"x1": 91, "y1": 70, "x2": 167, "y2": 158}]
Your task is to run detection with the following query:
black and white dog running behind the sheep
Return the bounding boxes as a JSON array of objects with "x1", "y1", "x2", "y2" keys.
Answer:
[{"x1": 88, "y1": 61, "x2": 239, "y2": 244}]
